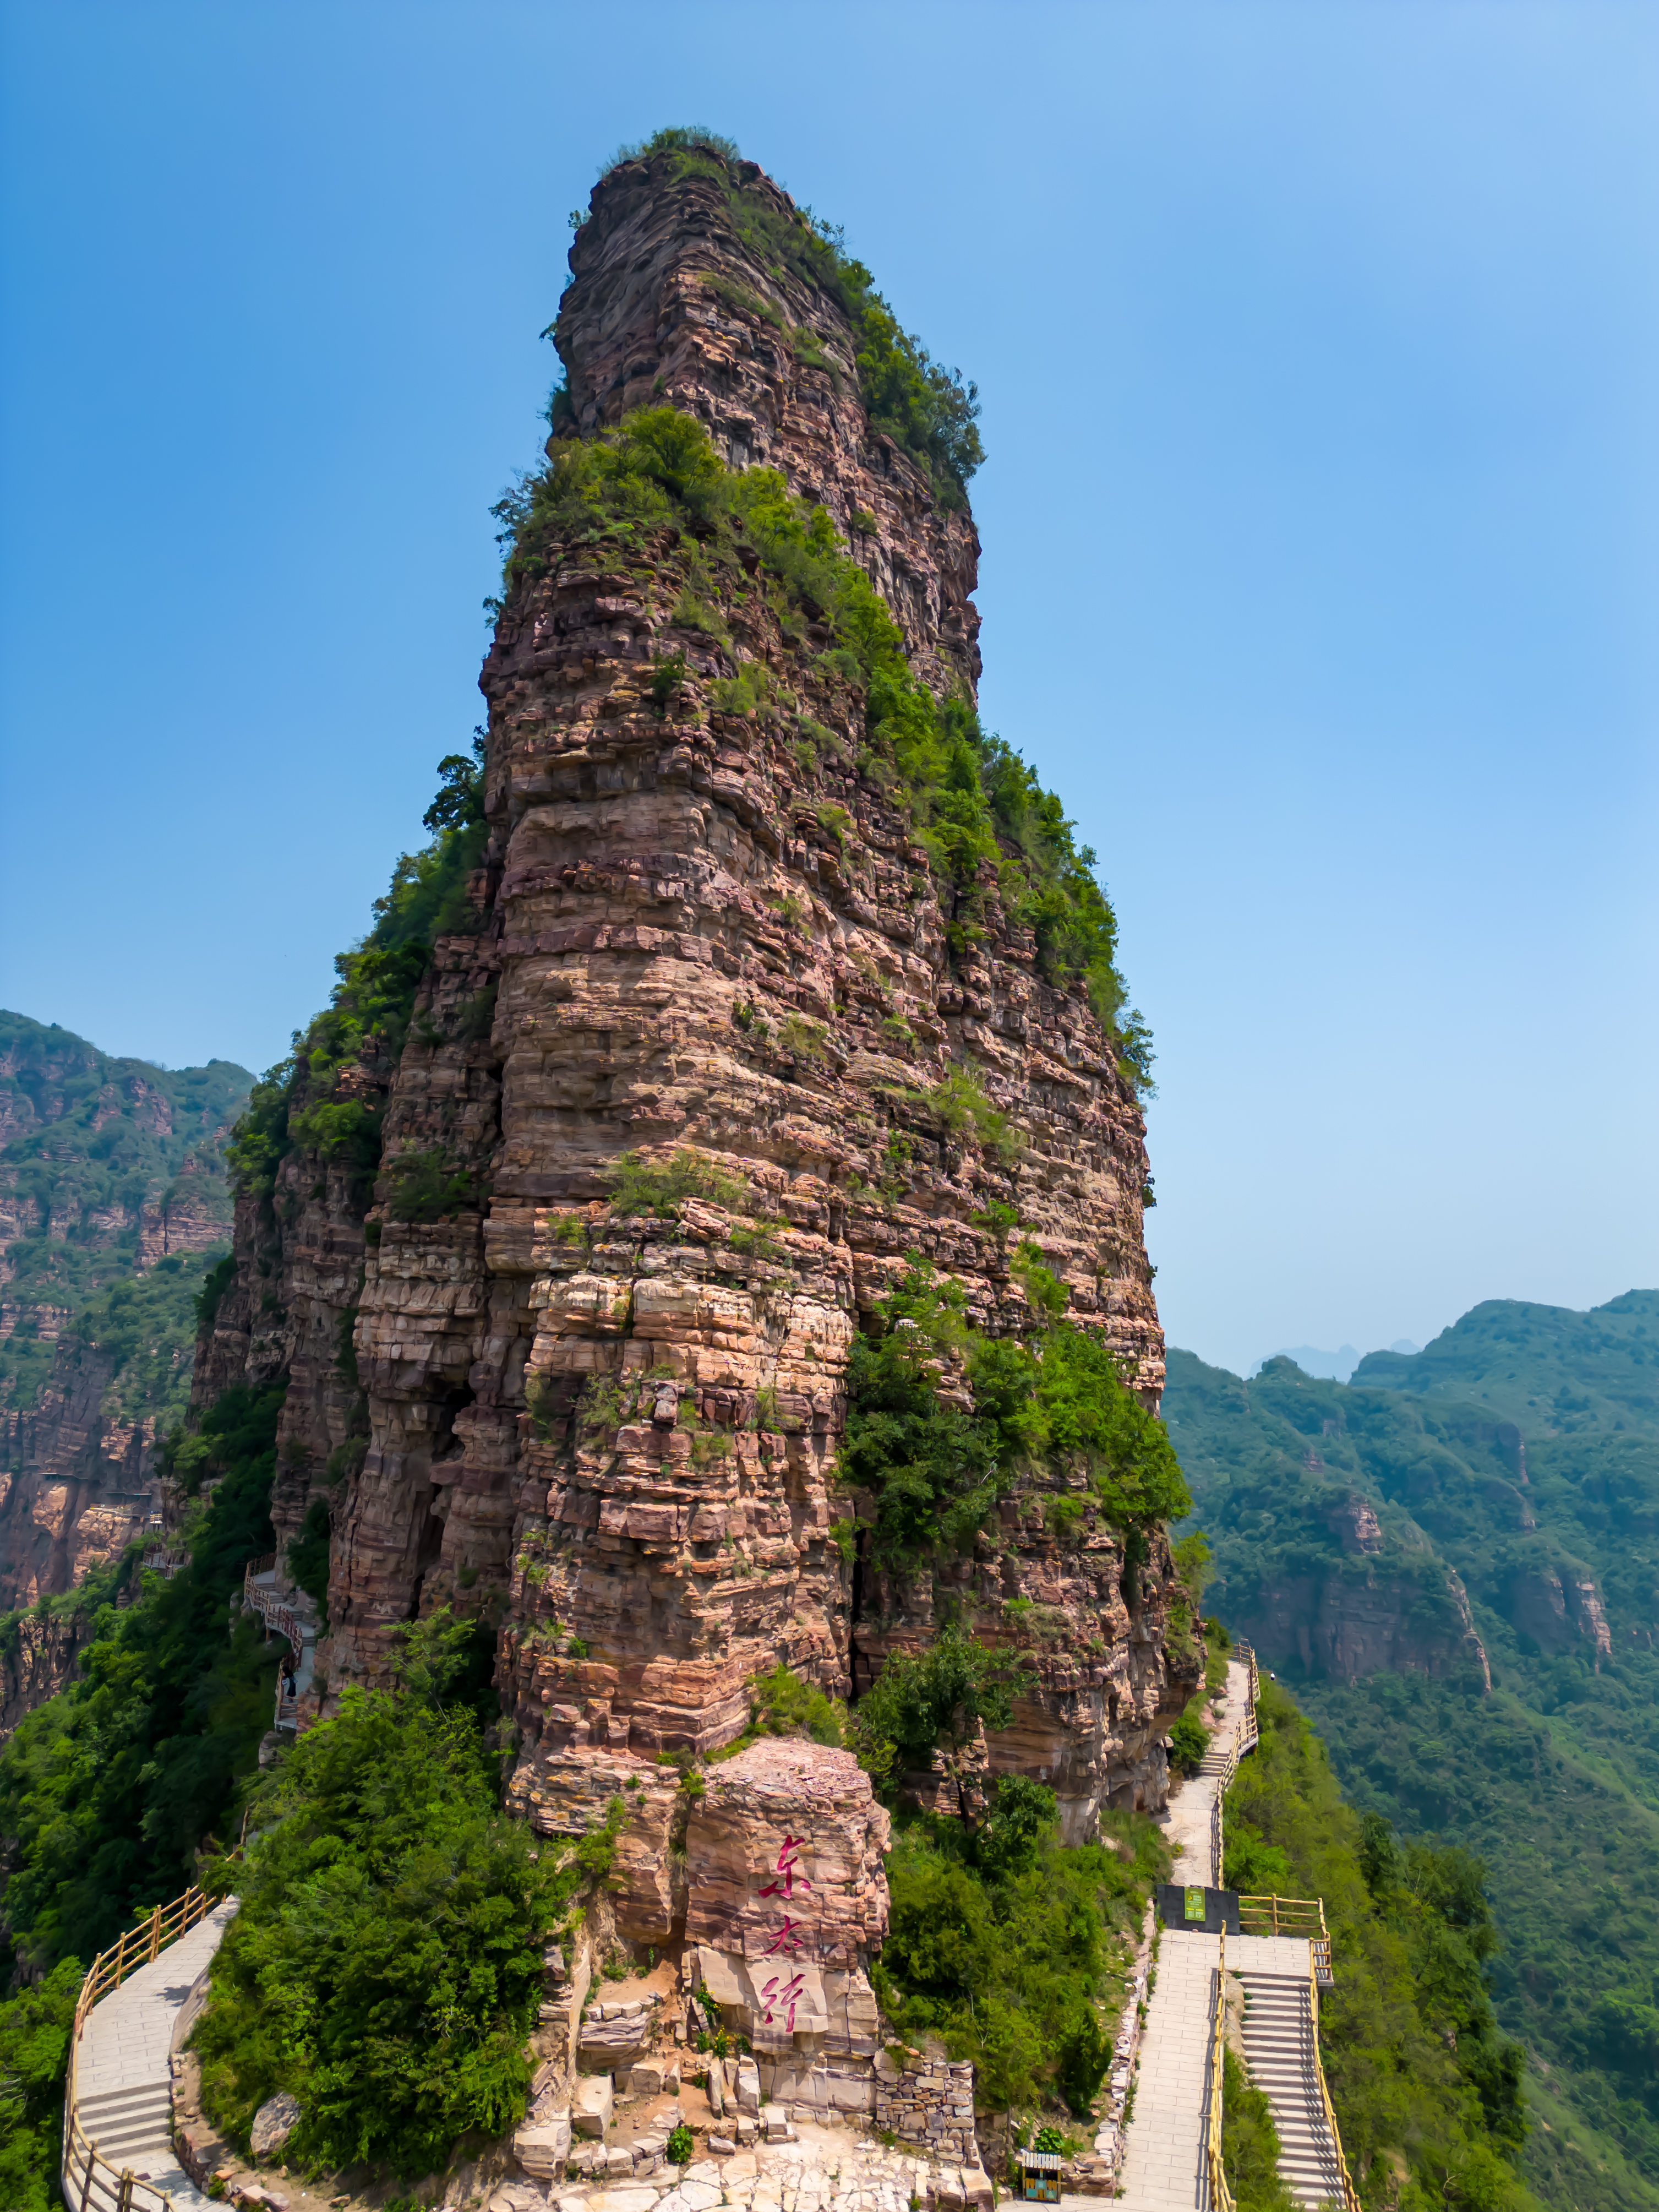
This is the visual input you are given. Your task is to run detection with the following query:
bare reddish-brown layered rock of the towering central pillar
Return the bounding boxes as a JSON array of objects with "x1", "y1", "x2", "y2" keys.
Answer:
[{"x1": 197, "y1": 138, "x2": 1201, "y2": 1831}]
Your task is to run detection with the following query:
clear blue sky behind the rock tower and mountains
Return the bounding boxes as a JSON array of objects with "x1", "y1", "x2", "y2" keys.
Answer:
[{"x1": 0, "y1": 0, "x2": 1659, "y2": 1367}]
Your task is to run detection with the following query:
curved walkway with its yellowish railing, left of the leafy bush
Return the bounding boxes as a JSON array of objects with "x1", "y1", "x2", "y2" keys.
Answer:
[{"x1": 62, "y1": 1898, "x2": 237, "y2": 2212}]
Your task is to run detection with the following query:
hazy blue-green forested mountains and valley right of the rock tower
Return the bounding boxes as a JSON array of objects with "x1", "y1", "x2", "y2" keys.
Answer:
[{"x1": 1164, "y1": 1292, "x2": 1659, "y2": 2208}]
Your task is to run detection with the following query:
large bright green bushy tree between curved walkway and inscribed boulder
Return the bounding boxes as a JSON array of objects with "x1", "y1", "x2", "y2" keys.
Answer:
[{"x1": 195, "y1": 1615, "x2": 566, "y2": 2175}]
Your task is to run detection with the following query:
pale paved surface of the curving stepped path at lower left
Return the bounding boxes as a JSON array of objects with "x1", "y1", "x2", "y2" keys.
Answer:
[{"x1": 64, "y1": 1898, "x2": 237, "y2": 2212}]
